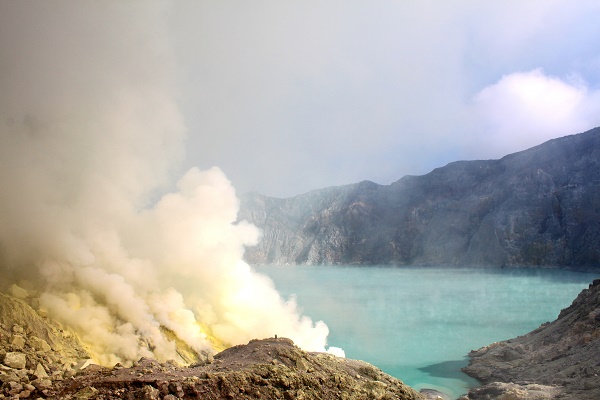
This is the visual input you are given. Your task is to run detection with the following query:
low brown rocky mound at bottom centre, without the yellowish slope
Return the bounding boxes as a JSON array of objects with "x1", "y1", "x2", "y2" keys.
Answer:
[{"x1": 52, "y1": 338, "x2": 424, "y2": 400}]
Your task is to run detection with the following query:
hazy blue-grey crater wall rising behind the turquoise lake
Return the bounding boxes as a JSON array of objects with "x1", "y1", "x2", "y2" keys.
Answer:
[{"x1": 239, "y1": 128, "x2": 600, "y2": 269}]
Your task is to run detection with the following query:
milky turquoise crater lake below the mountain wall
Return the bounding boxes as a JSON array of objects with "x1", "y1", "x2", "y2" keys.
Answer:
[{"x1": 256, "y1": 266, "x2": 599, "y2": 398}]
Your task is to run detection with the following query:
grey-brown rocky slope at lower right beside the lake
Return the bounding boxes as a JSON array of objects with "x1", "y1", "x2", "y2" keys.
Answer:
[{"x1": 464, "y1": 280, "x2": 600, "y2": 400}]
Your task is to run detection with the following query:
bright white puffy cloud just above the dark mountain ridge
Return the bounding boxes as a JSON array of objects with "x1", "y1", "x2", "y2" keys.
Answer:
[{"x1": 473, "y1": 69, "x2": 600, "y2": 157}]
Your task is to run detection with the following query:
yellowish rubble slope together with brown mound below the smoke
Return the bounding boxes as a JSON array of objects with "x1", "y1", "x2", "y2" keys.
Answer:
[{"x1": 0, "y1": 294, "x2": 425, "y2": 400}]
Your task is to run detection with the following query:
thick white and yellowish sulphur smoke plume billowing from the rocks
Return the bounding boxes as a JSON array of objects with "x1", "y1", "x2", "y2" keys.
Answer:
[{"x1": 0, "y1": 1, "x2": 328, "y2": 364}]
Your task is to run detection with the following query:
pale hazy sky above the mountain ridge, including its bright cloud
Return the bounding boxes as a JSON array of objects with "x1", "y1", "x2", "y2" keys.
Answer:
[{"x1": 5, "y1": 0, "x2": 600, "y2": 197}]
